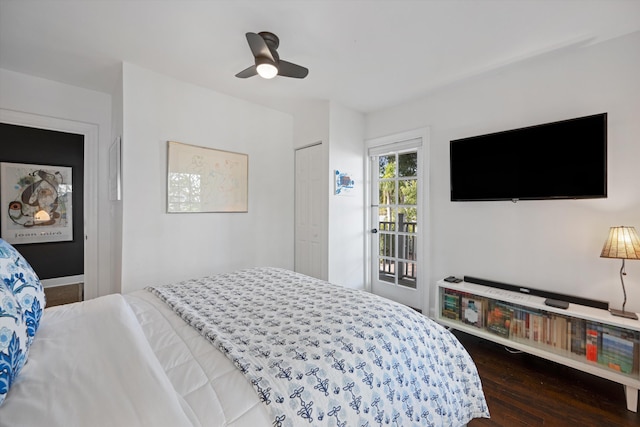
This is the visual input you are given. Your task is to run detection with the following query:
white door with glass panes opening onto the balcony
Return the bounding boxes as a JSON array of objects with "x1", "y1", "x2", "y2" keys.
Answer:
[{"x1": 369, "y1": 138, "x2": 424, "y2": 310}]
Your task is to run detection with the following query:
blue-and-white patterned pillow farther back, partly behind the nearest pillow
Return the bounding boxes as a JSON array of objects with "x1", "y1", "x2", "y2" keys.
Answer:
[{"x1": 0, "y1": 239, "x2": 46, "y2": 347}]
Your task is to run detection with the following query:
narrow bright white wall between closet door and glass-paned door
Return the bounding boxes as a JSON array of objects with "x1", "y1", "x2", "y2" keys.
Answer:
[{"x1": 328, "y1": 102, "x2": 365, "y2": 289}]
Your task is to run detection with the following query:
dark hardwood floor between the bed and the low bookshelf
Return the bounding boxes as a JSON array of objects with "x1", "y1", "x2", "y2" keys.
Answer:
[{"x1": 454, "y1": 331, "x2": 640, "y2": 427}]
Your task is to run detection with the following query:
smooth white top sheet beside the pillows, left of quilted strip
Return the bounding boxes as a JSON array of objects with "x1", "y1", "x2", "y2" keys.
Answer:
[{"x1": 0, "y1": 295, "x2": 193, "y2": 427}]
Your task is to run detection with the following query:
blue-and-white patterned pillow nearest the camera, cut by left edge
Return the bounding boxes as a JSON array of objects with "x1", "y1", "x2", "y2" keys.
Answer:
[{"x1": 0, "y1": 282, "x2": 29, "y2": 405}]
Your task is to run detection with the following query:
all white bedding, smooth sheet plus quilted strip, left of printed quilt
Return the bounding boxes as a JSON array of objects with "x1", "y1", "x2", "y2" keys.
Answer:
[{"x1": 0, "y1": 273, "x2": 488, "y2": 427}]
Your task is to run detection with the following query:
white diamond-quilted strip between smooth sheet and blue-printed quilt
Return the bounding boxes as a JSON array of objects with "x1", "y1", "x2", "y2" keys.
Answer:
[{"x1": 125, "y1": 290, "x2": 271, "y2": 427}]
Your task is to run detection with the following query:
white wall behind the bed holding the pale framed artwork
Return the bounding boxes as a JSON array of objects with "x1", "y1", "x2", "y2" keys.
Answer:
[{"x1": 122, "y1": 63, "x2": 294, "y2": 292}]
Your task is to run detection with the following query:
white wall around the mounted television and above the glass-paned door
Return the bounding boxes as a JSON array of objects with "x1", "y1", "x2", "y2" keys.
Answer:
[{"x1": 366, "y1": 33, "x2": 640, "y2": 312}]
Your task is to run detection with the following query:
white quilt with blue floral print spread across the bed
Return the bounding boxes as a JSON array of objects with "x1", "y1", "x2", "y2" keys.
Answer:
[{"x1": 147, "y1": 268, "x2": 489, "y2": 427}]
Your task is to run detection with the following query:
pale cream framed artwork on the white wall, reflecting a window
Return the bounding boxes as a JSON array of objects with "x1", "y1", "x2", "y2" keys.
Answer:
[{"x1": 167, "y1": 141, "x2": 249, "y2": 213}]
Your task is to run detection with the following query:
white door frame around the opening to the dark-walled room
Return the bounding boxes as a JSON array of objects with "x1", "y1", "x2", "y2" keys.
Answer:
[{"x1": 0, "y1": 108, "x2": 98, "y2": 299}]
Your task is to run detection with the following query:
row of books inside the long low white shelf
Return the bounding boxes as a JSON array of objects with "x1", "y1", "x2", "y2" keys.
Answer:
[{"x1": 441, "y1": 288, "x2": 640, "y2": 374}]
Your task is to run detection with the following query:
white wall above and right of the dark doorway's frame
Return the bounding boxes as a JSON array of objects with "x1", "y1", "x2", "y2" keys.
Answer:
[{"x1": 0, "y1": 69, "x2": 116, "y2": 297}]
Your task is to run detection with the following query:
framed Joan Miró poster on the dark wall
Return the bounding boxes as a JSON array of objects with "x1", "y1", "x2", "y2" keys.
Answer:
[{"x1": 0, "y1": 162, "x2": 73, "y2": 244}]
